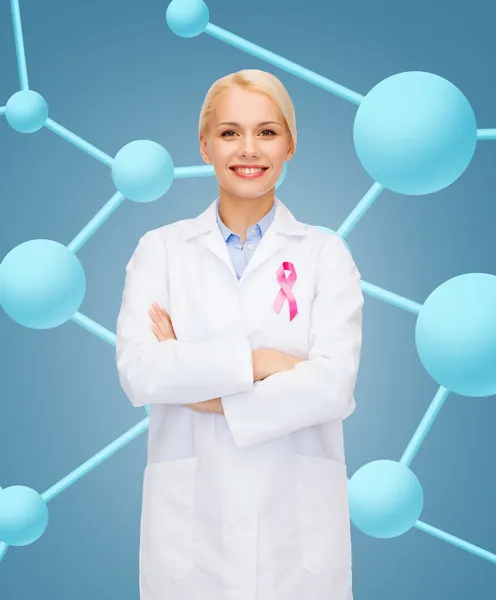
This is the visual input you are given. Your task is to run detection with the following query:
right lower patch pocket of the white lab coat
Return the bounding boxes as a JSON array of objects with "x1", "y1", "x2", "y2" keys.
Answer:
[{"x1": 296, "y1": 453, "x2": 351, "y2": 574}]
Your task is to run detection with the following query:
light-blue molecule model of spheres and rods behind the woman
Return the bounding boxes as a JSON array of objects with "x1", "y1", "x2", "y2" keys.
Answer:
[{"x1": 0, "y1": 0, "x2": 496, "y2": 584}]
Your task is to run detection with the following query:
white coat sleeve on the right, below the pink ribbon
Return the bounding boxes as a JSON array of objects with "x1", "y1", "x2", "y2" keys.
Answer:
[{"x1": 221, "y1": 235, "x2": 364, "y2": 448}]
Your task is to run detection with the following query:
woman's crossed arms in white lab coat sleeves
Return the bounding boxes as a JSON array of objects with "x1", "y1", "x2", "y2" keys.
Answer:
[{"x1": 116, "y1": 230, "x2": 363, "y2": 448}]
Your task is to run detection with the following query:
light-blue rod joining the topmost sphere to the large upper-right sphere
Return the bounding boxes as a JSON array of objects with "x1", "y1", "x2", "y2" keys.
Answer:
[{"x1": 205, "y1": 23, "x2": 364, "y2": 105}]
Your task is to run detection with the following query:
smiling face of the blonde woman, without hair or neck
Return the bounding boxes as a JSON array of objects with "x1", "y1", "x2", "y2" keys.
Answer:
[{"x1": 200, "y1": 86, "x2": 294, "y2": 198}]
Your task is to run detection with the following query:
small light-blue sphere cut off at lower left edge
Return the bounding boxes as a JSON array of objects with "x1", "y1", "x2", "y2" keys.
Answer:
[{"x1": 0, "y1": 485, "x2": 48, "y2": 546}]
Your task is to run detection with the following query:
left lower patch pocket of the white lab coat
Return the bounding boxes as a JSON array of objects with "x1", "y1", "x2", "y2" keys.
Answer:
[{"x1": 140, "y1": 456, "x2": 198, "y2": 579}]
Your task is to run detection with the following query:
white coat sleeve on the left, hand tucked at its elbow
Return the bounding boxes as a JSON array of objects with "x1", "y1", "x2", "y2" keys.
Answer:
[{"x1": 116, "y1": 230, "x2": 253, "y2": 407}]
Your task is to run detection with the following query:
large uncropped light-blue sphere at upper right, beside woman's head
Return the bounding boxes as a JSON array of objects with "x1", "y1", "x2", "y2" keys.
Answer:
[{"x1": 353, "y1": 71, "x2": 477, "y2": 195}]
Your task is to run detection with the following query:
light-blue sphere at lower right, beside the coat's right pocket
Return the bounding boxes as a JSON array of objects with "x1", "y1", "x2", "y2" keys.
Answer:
[{"x1": 348, "y1": 460, "x2": 424, "y2": 538}]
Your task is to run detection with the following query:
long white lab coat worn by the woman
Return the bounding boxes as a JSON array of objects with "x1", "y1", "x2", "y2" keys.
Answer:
[{"x1": 116, "y1": 197, "x2": 363, "y2": 600}]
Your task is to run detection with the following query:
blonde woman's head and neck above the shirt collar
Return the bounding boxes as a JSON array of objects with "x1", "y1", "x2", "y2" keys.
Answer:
[{"x1": 198, "y1": 69, "x2": 297, "y2": 241}]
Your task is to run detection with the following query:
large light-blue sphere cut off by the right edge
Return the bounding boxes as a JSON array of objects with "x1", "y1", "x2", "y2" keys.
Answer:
[{"x1": 415, "y1": 273, "x2": 496, "y2": 397}]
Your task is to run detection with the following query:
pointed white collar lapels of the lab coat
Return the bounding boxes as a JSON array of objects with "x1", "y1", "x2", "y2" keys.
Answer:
[{"x1": 186, "y1": 197, "x2": 308, "y2": 283}]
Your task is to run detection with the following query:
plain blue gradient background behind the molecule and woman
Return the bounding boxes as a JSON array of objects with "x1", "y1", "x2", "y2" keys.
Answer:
[{"x1": 0, "y1": 0, "x2": 496, "y2": 600}]
